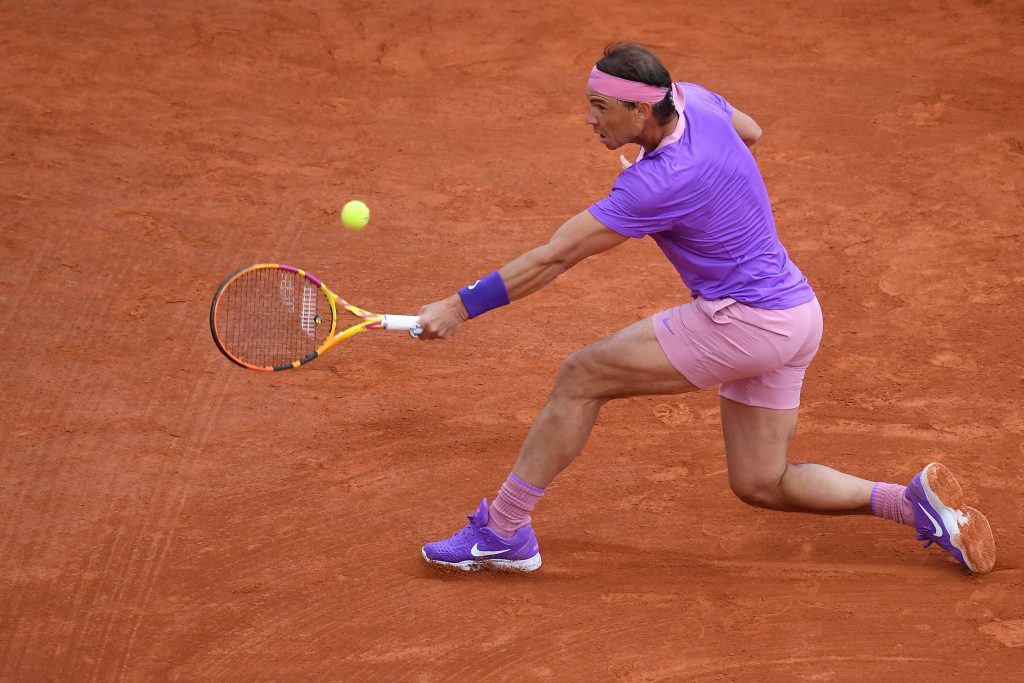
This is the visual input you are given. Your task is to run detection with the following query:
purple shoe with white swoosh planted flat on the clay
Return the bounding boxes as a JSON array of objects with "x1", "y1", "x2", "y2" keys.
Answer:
[{"x1": 423, "y1": 499, "x2": 541, "y2": 571}]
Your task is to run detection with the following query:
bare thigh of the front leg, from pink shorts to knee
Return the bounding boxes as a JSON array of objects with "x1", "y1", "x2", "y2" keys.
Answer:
[{"x1": 555, "y1": 317, "x2": 697, "y2": 398}]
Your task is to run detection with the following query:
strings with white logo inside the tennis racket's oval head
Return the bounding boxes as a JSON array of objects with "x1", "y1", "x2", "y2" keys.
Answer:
[{"x1": 217, "y1": 268, "x2": 332, "y2": 368}]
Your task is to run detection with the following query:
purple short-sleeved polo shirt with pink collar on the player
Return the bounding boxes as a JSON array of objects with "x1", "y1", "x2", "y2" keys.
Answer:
[{"x1": 590, "y1": 83, "x2": 814, "y2": 309}]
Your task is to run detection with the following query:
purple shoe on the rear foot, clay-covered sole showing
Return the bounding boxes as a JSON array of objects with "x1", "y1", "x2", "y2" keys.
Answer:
[{"x1": 906, "y1": 463, "x2": 995, "y2": 573}]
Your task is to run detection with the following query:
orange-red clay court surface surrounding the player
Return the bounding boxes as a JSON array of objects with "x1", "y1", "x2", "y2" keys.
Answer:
[{"x1": 0, "y1": 0, "x2": 1024, "y2": 681}]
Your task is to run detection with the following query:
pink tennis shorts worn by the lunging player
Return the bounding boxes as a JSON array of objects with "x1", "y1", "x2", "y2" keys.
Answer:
[{"x1": 653, "y1": 297, "x2": 822, "y2": 410}]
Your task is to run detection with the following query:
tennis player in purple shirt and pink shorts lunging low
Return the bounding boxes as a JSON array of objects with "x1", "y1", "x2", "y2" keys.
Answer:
[{"x1": 420, "y1": 43, "x2": 995, "y2": 573}]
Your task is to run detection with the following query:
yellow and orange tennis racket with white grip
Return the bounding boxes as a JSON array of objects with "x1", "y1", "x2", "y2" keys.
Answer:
[{"x1": 210, "y1": 263, "x2": 422, "y2": 371}]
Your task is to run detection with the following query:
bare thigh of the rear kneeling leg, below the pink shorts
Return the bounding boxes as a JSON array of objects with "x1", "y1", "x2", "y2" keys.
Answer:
[{"x1": 719, "y1": 397, "x2": 800, "y2": 494}]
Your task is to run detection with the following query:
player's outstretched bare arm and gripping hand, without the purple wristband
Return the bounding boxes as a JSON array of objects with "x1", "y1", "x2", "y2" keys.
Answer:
[{"x1": 420, "y1": 211, "x2": 629, "y2": 339}]
